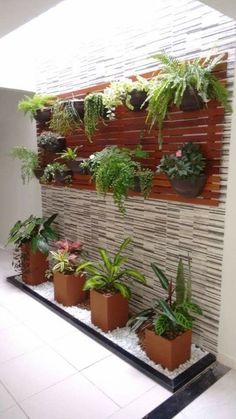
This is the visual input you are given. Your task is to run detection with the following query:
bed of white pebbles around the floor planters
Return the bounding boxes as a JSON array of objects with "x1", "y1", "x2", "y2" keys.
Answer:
[{"x1": 17, "y1": 277, "x2": 208, "y2": 379}]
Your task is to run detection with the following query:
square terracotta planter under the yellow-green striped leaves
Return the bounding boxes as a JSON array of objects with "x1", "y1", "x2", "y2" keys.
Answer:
[{"x1": 90, "y1": 290, "x2": 129, "y2": 332}]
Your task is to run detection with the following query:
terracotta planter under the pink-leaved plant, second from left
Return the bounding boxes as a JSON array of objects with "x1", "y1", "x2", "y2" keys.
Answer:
[{"x1": 53, "y1": 272, "x2": 86, "y2": 306}]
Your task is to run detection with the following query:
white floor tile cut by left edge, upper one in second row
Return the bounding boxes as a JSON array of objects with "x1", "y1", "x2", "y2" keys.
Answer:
[{"x1": 0, "y1": 324, "x2": 44, "y2": 364}]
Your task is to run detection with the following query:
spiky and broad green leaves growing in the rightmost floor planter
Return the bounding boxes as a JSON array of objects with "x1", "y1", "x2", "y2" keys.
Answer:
[{"x1": 127, "y1": 257, "x2": 202, "y2": 339}]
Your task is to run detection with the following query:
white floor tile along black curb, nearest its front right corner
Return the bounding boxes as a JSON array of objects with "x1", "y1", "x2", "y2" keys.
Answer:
[{"x1": 82, "y1": 355, "x2": 156, "y2": 406}]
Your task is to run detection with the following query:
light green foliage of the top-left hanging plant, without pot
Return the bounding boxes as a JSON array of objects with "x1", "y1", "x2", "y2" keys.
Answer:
[{"x1": 18, "y1": 93, "x2": 56, "y2": 119}]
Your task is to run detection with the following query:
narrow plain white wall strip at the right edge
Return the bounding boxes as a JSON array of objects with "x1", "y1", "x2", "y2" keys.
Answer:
[{"x1": 218, "y1": 68, "x2": 236, "y2": 368}]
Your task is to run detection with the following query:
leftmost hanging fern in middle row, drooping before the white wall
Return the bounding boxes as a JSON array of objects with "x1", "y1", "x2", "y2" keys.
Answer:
[{"x1": 10, "y1": 146, "x2": 43, "y2": 184}]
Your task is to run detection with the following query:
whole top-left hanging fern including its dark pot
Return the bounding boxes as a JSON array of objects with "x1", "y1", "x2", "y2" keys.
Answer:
[{"x1": 18, "y1": 93, "x2": 56, "y2": 124}]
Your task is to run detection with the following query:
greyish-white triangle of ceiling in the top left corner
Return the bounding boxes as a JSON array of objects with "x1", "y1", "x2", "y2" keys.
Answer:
[{"x1": 0, "y1": 0, "x2": 61, "y2": 38}]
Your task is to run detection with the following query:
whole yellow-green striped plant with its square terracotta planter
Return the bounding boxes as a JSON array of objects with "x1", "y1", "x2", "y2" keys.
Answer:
[{"x1": 77, "y1": 238, "x2": 146, "y2": 332}]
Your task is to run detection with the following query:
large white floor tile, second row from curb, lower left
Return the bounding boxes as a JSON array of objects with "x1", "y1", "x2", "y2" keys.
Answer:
[{"x1": 0, "y1": 347, "x2": 76, "y2": 400}]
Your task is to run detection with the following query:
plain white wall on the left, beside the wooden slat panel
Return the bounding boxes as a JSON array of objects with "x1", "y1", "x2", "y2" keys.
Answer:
[{"x1": 0, "y1": 89, "x2": 41, "y2": 245}]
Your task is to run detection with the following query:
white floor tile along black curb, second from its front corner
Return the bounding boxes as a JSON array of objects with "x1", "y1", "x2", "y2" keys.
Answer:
[{"x1": 51, "y1": 331, "x2": 111, "y2": 371}]
